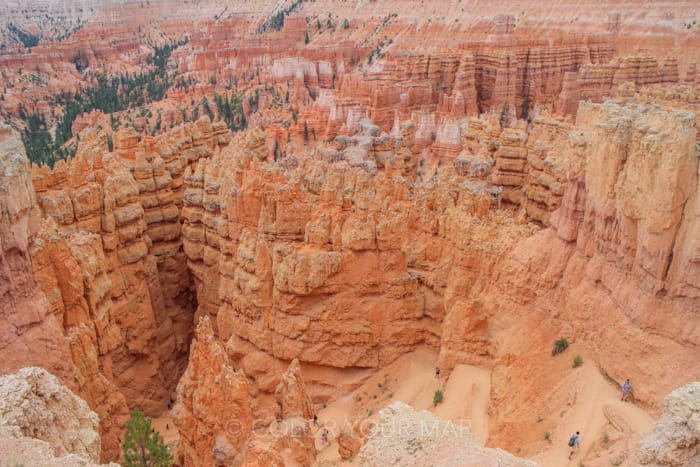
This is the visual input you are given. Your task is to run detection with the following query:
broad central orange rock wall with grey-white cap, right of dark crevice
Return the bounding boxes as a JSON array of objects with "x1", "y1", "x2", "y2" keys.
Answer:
[{"x1": 183, "y1": 119, "x2": 532, "y2": 418}]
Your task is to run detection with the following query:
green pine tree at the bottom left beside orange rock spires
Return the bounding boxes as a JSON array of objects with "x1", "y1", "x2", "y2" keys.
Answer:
[{"x1": 122, "y1": 409, "x2": 173, "y2": 467}]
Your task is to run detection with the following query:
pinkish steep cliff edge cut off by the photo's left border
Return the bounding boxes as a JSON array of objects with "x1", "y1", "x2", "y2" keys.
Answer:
[{"x1": 0, "y1": 124, "x2": 75, "y2": 388}]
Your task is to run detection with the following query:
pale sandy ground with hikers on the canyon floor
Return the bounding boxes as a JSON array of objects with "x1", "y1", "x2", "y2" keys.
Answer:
[{"x1": 153, "y1": 349, "x2": 653, "y2": 467}]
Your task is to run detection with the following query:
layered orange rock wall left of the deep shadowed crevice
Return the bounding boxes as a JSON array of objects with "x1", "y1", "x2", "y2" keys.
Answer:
[{"x1": 26, "y1": 122, "x2": 232, "y2": 458}]
